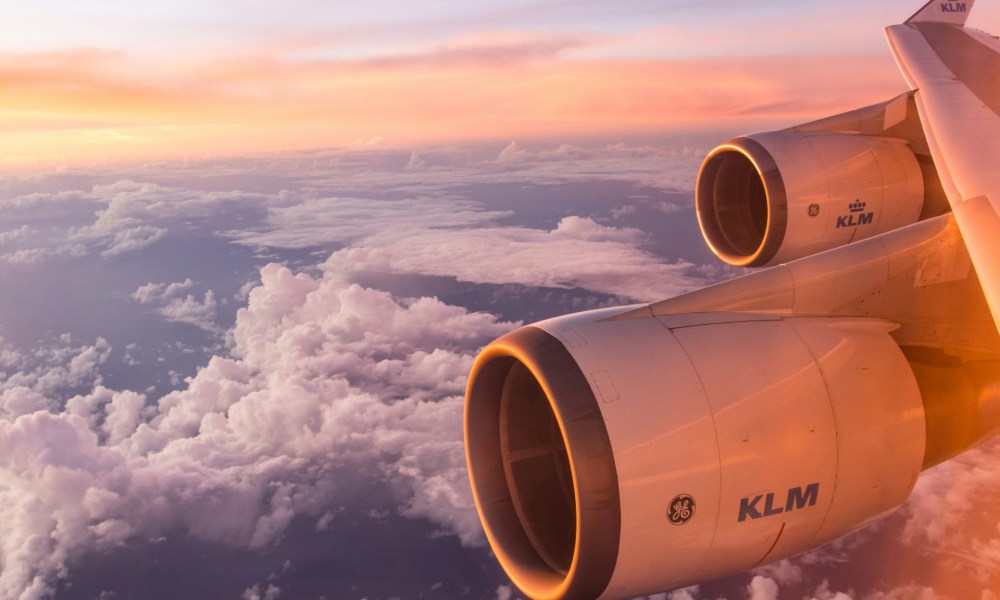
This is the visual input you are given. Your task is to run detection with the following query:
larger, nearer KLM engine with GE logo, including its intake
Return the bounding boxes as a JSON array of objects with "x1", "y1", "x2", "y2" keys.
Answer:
[{"x1": 465, "y1": 309, "x2": 925, "y2": 598}]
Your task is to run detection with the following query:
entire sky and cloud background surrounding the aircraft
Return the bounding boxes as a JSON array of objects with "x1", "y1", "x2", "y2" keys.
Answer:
[{"x1": 0, "y1": 0, "x2": 1000, "y2": 600}]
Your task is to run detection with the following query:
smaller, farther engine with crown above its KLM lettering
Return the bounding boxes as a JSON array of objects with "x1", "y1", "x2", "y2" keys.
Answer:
[{"x1": 696, "y1": 129, "x2": 924, "y2": 267}]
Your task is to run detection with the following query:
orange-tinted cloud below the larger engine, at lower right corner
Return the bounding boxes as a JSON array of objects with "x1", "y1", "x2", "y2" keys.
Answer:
[{"x1": 736, "y1": 439, "x2": 1000, "y2": 600}]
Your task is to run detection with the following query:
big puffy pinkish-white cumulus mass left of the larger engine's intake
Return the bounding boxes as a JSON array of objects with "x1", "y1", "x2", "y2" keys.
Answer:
[{"x1": 0, "y1": 264, "x2": 512, "y2": 598}]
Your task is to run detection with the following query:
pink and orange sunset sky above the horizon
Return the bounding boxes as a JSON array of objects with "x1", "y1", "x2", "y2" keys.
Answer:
[{"x1": 7, "y1": 0, "x2": 1000, "y2": 167}]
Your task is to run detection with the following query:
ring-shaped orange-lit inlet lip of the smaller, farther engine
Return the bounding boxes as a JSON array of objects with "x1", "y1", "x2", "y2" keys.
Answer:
[{"x1": 695, "y1": 137, "x2": 788, "y2": 267}]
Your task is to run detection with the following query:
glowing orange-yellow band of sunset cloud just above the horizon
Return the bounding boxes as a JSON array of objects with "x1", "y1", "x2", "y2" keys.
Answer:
[{"x1": 0, "y1": 45, "x2": 905, "y2": 166}]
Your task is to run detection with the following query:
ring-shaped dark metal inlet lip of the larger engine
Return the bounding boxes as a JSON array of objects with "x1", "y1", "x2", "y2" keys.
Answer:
[{"x1": 465, "y1": 326, "x2": 621, "y2": 599}]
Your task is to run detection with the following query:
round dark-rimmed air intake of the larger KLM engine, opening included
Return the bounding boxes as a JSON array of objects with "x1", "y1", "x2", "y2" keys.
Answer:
[{"x1": 465, "y1": 327, "x2": 621, "y2": 598}]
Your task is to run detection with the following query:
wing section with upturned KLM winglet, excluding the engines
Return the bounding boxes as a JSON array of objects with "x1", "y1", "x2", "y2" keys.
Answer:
[{"x1": 886, "y1": 0, "x2": 1000, "y2": 326}]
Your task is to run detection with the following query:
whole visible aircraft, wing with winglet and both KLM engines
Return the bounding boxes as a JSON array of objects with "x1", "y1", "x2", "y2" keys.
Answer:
[{"x1": 464, "y1": 0, "x2": 1000, "y2": 600}]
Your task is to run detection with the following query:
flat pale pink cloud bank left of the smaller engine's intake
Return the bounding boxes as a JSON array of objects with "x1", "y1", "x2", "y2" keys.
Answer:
[{"x1": 324, "y1": 217, "x2": 702, "y2": 301}]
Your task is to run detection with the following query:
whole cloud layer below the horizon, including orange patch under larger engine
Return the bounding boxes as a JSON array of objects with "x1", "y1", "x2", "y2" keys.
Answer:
[{"x1": 0, "y1": 141, "x2": 1000, "y2": 600}]
